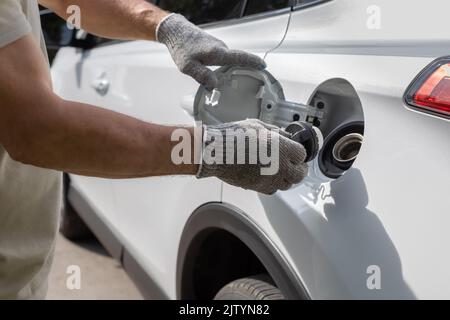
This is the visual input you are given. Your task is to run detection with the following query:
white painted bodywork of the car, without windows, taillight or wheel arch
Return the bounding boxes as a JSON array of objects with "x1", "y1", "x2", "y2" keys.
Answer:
[{"x1": 53, "y1": 0, "x2": 450, "y2": 299}]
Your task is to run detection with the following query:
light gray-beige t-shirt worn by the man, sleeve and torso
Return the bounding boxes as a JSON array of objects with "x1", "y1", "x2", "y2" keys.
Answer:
[{"x1": 0, "y1": 0, "x2": 62, "y2": 299}]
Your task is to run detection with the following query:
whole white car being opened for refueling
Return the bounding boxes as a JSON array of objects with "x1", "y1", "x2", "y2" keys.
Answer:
[{"x1": 52, "y1": 0, "x2": 450, "y2": 299}]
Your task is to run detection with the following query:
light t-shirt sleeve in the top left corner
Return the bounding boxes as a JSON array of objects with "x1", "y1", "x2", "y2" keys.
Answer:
[{"x1": 0, "y1": 0, "x2": 31, "y2": 48}]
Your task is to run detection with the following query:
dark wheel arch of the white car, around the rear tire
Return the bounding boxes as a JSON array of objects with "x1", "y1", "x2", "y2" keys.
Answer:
[{"x1": 176, "y1": 202, "x2": 310, "y2": 299}]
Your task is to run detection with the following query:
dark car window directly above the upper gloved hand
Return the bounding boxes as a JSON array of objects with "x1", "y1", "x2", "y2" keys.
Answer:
[{"x1": 158, "y1": 0, "x2": 245, "y2": 24}]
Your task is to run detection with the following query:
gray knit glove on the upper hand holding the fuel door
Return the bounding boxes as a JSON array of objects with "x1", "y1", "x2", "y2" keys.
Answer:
[{"x1": 156, "y1": 14, "x2": 266, "y2": 90}]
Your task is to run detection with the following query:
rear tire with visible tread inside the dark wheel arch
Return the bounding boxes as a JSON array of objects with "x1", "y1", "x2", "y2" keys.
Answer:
[{"x1": 214, "y1": 274, "x2": 285, "y2": 300}]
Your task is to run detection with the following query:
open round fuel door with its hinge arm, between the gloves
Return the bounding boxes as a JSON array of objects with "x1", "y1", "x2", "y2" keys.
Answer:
[{"x1": 193, "y1": 67, "x2": 325, "y2": 128}]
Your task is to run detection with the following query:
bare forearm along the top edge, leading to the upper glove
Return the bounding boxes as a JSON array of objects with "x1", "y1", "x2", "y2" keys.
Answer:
[{"x1": 39, "y1": 0, "x2": 168, "y2": 40}]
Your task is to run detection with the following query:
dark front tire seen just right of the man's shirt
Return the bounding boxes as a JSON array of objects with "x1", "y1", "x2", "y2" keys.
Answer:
[{"x1": 59, "y1": 174, "x2": 94, "y2": 241}]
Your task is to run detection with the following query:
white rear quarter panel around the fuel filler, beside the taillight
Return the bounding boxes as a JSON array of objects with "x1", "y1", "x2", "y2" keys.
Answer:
[{"x1": 223, "y1": 0, "x2": 450, "y2": 299}]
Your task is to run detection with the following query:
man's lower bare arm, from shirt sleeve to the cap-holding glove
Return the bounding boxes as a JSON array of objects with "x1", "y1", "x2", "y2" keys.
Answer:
[{"x1": 0, "y1": 35, "x2": 197, "y2": 178}]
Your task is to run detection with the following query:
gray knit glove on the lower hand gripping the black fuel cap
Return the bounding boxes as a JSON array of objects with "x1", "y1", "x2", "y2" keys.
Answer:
[{"x1": 197, "y1": 120, "x2": 308, "y2": 195}]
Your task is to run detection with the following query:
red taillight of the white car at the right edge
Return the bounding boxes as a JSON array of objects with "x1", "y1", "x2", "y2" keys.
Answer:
[{"x1": 405, "y1": 58, "x2": 450, "y2": 118}]
